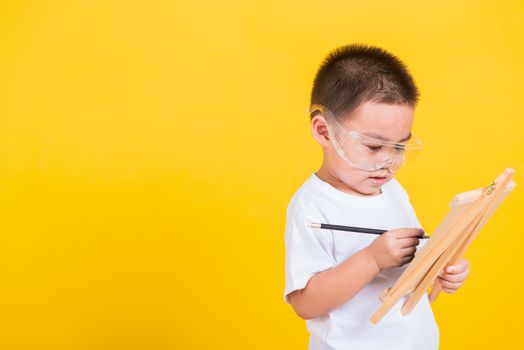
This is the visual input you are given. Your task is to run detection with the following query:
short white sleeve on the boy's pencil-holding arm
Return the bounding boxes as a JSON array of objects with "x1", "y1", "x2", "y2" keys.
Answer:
[{"x1": 284, "y1": 209, "x2": 335, "y2": 303}]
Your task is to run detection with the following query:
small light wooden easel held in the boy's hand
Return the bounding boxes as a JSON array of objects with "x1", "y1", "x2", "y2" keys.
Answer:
[{"x1": 370, "y1": 168, "x2": 515, "y2": 324}]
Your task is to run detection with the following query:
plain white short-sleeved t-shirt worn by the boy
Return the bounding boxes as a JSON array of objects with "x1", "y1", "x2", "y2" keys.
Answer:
[{"x1": 284, "y1": 173, "x2": 439, "y2": 350}]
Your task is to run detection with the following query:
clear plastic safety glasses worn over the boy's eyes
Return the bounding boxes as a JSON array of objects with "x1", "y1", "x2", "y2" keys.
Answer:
[{"x1": 309, "y1": 104, "x2": 422, "y2": 173}]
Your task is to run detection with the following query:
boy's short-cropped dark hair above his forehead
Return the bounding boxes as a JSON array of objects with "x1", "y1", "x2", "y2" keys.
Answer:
[{"x1": 311, "y1": 44, "x2": 419, "y2": 117}]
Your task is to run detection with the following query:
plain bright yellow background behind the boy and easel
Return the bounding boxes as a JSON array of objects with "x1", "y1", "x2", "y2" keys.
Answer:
[{"x1": 0, "y1": 0, "x2": 524, "y2": 349}]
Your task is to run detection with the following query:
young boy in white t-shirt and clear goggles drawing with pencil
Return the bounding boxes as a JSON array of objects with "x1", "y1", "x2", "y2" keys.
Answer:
[{"x1": 284, "y1": 45, "x2": 469, "y2": 350}]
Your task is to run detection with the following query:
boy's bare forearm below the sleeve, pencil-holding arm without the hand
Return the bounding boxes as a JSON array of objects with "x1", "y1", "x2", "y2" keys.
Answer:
[{"x1": 290, "y1": 248, "x2": 380, "y2": 319}]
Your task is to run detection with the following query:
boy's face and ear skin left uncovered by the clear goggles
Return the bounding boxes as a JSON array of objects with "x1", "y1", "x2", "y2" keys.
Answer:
[{"x1": 311, "y1": 101, "x2": 414, "y2": 195}]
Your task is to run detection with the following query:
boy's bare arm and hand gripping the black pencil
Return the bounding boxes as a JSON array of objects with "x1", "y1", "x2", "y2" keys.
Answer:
[{"x1": 288, "y1": 228, "x2": 424, "y2": 320}]
